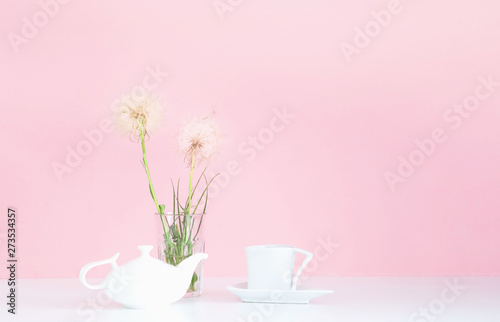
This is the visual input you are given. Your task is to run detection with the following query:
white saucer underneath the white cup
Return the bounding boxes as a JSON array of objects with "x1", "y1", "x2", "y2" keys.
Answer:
[{"x1": 227, "y1": 283, "x2": 333, "y2": 304}]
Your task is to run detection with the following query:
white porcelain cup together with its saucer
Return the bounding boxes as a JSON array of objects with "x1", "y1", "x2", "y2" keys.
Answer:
[{"x1": 227, "y1": 245, "x2": 333, "y2": 304}]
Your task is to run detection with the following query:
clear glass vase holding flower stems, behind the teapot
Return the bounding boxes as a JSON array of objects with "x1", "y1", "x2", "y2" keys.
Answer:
[{"x1": 155, "y1": 213, "x2": 207, "y2": 297}]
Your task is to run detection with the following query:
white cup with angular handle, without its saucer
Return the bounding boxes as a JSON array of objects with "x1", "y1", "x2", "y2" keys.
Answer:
[{"x1": 245, "y1": 245, "x2": 313, "y2": 290}]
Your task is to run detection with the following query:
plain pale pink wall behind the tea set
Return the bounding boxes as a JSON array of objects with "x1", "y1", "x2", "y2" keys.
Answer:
[{"x1": 0, "y1": 0, "x2": 500, "y2": 278}]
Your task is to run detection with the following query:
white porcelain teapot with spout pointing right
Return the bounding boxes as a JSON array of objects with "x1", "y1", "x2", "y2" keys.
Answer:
[{"x1": 80, "y1": 245, "x2": 208, "y2": 309}]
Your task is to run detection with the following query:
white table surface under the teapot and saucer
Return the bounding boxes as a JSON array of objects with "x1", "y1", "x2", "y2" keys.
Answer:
[{"x1": 0, "y1": 277, "x2": 500, "y2": 322}]
